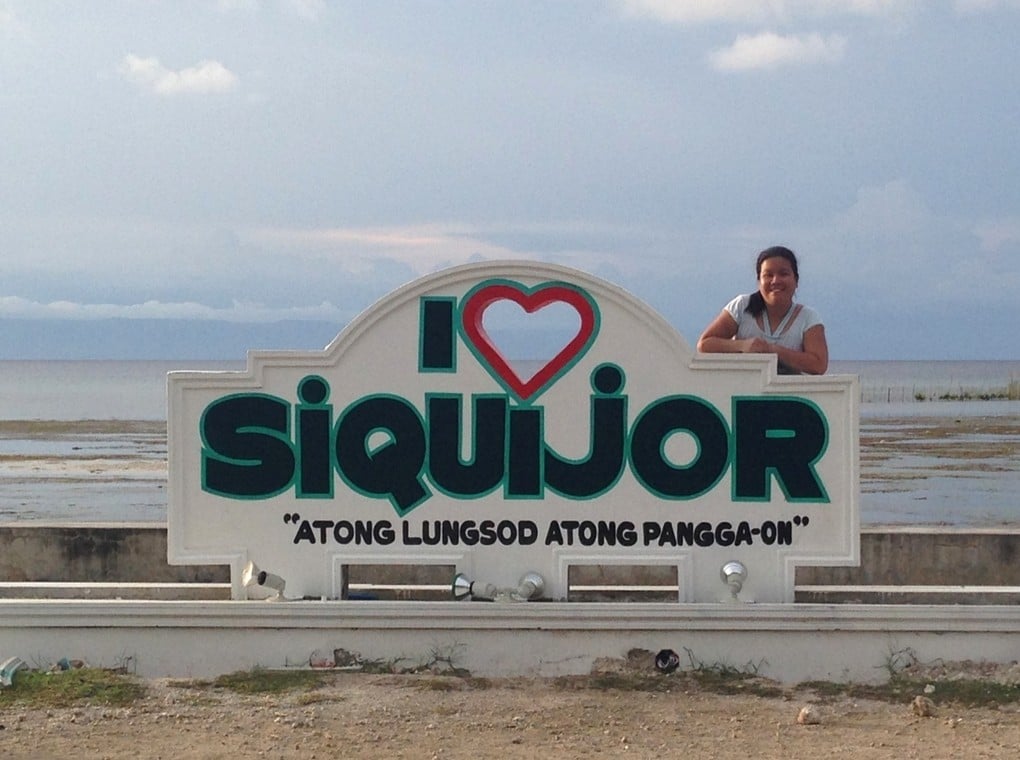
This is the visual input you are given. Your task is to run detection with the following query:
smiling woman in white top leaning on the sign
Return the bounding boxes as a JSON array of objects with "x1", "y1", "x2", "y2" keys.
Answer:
[{"x1": 698, "y1": 246, "x2": 828, "y2": 374}]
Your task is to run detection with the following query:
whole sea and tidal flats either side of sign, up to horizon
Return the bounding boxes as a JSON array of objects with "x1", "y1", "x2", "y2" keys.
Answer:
[{"x1": 0, "y1": 362, "x2": 1020, "y2": 526}]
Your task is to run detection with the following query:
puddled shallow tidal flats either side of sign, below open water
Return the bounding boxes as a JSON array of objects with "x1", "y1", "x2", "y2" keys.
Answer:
[{"x1": 0, "y1": 410, "x2": 1020, "y2": 526}]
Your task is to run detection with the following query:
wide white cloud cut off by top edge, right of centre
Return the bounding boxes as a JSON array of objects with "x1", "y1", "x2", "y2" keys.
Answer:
[{"x1": 619, "y1": 0, "x2": 918, "y2": 23}]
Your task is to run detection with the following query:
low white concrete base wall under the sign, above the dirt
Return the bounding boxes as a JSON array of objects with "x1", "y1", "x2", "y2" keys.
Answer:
[{"x1": 0, "y1": 600, "x2": 1020, "y2": 682}]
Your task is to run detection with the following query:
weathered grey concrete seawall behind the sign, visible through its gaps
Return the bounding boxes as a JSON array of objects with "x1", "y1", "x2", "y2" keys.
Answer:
[{"x1": 0, "y1": 523, "x2": 1020, "y2": 604}]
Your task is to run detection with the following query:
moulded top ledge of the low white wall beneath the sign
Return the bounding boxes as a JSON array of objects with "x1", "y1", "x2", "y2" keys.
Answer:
[{"x1": 11, "y1": 599, "x2": 1020, "y2": 637}]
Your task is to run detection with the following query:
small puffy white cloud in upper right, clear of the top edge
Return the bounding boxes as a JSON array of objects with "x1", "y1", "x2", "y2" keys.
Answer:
[{"x1": 709, "y1": 32, "x2": 847, "y2": 71}]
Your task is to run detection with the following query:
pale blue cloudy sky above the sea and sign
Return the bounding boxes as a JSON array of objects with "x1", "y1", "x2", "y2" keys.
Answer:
[{"x1": 0, "y1": 0, "x2": 1020, "y2": 359}]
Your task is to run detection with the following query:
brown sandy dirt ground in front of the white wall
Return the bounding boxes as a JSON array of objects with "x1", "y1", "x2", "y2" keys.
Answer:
[{"x1": 0, "y1": 656, "x2": 1020, "y2": 760}]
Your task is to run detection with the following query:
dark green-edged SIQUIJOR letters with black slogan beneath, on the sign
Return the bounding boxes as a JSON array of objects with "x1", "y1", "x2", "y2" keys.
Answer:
[{"x1": 200, "y1": 363, "x2": 828, "y2": 512}]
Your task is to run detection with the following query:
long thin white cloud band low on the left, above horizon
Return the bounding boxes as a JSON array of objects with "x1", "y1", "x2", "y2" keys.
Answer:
[{"x1": 0, "y1": 296, "x2": 350, "y2": 322}]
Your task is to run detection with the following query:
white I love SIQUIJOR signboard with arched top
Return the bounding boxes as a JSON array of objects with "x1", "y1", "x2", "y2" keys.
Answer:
[{"x1": 168, "y1": 262, "x2": 859, "y2": 602}]
